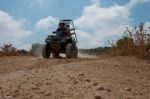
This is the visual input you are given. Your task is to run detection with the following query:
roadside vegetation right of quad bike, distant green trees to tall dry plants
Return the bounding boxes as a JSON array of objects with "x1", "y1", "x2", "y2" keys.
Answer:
[{"x1": 79, "y1": 23, "x2": 150, "y2": 59}]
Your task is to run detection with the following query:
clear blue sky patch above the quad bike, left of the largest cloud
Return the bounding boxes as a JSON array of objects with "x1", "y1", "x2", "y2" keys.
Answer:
[{"x1": 0, "y1": 0, "x2": 90, "y2": 22}]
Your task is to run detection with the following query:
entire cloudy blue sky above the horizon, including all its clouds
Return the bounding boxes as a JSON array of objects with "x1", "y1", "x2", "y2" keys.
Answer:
[{"x1": 0, "y1": 0, "x2": 150, "y2": 49}]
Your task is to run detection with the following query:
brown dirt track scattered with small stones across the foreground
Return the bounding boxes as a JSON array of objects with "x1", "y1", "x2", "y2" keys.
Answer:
[{"x1": 0, "y1": 57, "x2": 150, "y2": 99}]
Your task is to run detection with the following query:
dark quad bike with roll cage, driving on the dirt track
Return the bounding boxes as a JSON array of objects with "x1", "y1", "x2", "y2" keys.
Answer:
[{"x1": 42, "y1": 20, "x2": 78, "y2": 59}]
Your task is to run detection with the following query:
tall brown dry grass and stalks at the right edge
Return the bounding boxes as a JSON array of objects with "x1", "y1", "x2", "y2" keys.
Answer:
[{"x1": 111, "y1": 24, "x2": 150, "y2": 59}]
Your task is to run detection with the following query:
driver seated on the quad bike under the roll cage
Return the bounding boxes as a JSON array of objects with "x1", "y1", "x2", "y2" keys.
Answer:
[{"x1": 56, "y1": 22, "x2": 71, "y2": 36}]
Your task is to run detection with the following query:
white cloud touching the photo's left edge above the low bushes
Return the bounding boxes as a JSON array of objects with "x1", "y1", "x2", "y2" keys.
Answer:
[{"x1": 0, "y1": 10, "x2": 32, "y2": 49}]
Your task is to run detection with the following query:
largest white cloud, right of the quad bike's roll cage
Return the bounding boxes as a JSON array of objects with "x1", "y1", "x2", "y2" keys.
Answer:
[{"x1": 75, "y1": 0, "x2": 150, "y2": 48}]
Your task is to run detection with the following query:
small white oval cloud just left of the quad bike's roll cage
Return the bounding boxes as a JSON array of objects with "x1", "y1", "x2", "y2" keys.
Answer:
[{"x1": 36, "y1": 16, "x2": 58, "y2": 30}]
